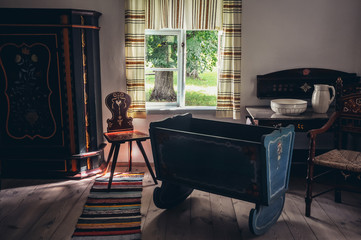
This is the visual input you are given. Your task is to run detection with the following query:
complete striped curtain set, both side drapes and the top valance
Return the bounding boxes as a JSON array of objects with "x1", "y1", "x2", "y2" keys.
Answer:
[{"x1": 125, "y1": 0, "x2": 242, "y2": 119}]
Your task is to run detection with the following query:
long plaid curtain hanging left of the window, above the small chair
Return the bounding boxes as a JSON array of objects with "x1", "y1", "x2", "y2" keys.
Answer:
[{"x1": 125, "y1": 0, "x2": 146, "y2": 118}]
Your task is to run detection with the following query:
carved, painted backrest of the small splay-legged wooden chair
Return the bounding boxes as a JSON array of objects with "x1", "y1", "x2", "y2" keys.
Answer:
[{"x1": 105, "y1": 92, "x2": 134, "y2": 132}]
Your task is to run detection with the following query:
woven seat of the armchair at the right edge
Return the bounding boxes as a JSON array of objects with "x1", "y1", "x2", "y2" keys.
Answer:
[{"x1": 314, "y1": 149, "x2": 361, "y2": 172}]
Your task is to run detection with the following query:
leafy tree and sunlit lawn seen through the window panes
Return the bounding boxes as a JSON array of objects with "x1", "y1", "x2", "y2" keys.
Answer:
[{"x1": 146, "y1": 31, "x2": 218, "y2": 106}]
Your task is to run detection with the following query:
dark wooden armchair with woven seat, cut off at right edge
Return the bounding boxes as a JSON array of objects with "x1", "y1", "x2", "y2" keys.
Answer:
[{"x1": 305, "y1": 78, "x2": 361, "y2": 217}]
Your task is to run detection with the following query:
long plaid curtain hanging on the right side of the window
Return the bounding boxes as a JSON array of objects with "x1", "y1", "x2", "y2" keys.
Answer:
[{"x1": 216, "y1": 0, "x2": 242, "y2": 119}]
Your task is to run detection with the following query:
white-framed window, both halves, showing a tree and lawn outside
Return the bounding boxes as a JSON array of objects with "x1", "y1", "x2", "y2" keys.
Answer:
[{"x1": 145, "y1": 30, "x2": 219, "y2": 107}]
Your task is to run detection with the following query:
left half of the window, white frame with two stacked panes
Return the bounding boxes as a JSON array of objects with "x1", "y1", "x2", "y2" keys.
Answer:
[{"x1": 145, "y1": 30, "x2": 184, "y2": 106}]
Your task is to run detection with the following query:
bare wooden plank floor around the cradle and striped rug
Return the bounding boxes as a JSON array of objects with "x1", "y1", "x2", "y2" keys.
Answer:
[{"x1": 0, "y1": 168, "x2": 361, "y2": 240}]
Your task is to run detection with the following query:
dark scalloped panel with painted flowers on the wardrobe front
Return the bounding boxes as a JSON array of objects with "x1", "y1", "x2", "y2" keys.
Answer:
[{"x1": 0, "y1": 43, "x2": 56, "y2": 140}]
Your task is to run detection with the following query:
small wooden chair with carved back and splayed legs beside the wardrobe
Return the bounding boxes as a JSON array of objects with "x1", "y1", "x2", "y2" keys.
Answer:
[{"x1": 104, "y1": 92, "x2": 157, "y2": 189}]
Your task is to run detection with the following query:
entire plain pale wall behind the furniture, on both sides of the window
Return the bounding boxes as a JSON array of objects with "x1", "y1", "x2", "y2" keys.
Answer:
[{"x1": 0, "y1": 0, "x2": 361, "y2": 161}]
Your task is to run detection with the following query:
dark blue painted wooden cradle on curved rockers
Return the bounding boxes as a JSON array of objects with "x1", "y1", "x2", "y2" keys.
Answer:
[{"x1": 149, "y1": 114, "x2": 295, "y2": 235}]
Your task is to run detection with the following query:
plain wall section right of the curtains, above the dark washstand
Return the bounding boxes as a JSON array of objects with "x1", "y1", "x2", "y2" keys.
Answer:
[{"x1": 241, "y1": 0, "x2": 361, "y2": 114}]
